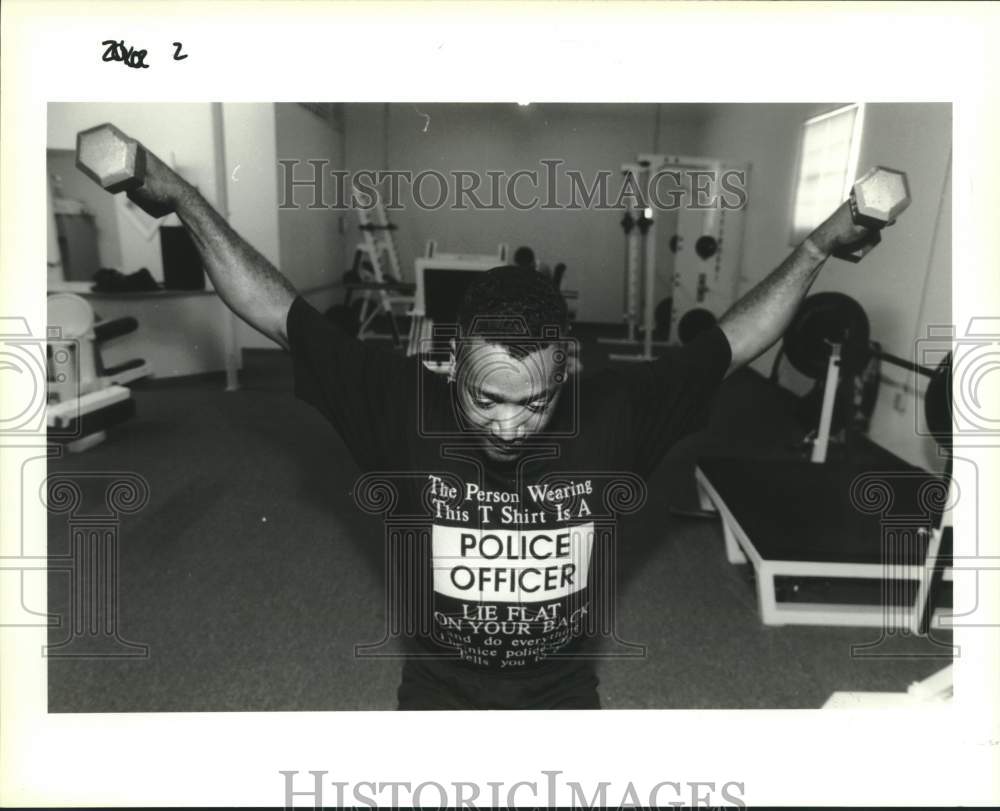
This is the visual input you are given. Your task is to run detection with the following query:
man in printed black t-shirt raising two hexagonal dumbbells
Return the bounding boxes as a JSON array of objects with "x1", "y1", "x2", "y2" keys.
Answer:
[{"x1": 78, "y1": 125, "x2": 909, "y2": 709}]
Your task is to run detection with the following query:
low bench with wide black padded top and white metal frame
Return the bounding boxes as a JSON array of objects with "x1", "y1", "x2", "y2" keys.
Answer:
[{"x1": 695, "y1": 457, "x2": 951, "y2": 630}]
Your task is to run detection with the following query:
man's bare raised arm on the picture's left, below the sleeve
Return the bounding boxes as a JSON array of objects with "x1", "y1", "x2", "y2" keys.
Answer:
[{"x1": 128, "y1": 150, "x2": 297, "y2": 349}]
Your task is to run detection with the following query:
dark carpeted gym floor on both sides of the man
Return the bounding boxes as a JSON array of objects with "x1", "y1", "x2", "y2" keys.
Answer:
[{"x1": 48, "y1": 328, "x2": 950, "y2": 712}]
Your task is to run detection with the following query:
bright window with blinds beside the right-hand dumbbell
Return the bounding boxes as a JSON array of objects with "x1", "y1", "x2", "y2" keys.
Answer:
[{"x1": 791, "y1": 104, "x2": 864, "y2": 244}]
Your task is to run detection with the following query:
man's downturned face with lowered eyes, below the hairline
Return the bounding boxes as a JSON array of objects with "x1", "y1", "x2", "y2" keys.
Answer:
[{"x1": 455, "y1": 338, "x2": 566, "y2": 462}]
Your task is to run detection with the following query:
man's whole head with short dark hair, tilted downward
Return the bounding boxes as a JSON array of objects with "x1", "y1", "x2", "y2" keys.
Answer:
[{"x1": 454, "y1": 266, "x2": 568, "y2": 462}]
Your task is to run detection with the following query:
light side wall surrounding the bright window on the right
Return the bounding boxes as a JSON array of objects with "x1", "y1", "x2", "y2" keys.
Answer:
[{"x1": 703, "y1": 104, "x2": 951, "y2": 468}]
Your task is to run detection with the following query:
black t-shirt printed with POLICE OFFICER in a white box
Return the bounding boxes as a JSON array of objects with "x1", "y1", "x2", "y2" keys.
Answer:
[{"x1": 287, "y1": 298, "x2": 731, "y2": 692}]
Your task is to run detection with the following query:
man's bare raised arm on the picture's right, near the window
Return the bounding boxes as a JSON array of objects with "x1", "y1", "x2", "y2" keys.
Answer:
[{"x1": 719, "y1": 198, "x2": 872, "y2": 374}]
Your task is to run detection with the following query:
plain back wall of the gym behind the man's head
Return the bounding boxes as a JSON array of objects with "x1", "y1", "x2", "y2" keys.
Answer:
[{"x1": 345, "y1": 104, "x2": 704, "y2": 323}]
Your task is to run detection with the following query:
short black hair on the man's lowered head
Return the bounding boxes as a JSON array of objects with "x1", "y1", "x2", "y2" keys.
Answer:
[{"x1": 458, "y1": 265, "x2": 569, "y2": 355}]
